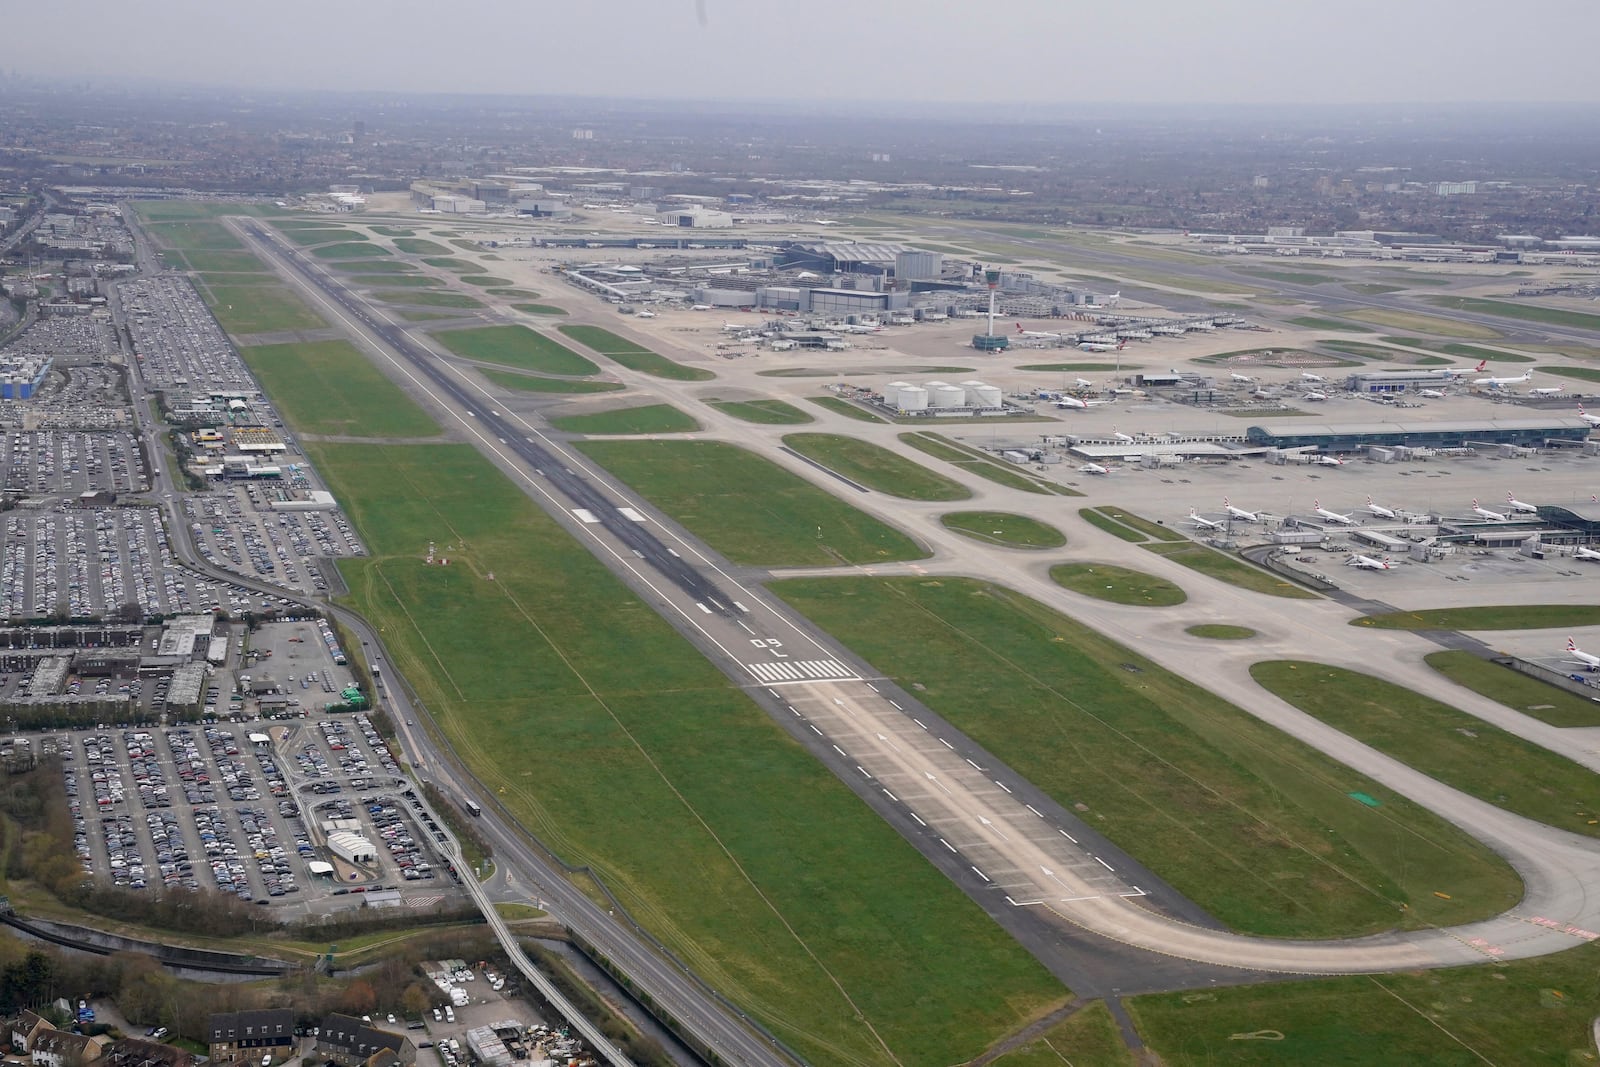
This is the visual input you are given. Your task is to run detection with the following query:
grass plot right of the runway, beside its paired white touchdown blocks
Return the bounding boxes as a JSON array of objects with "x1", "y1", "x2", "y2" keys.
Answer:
[{"x1": 578, "y1": 442, "x2": 928, "y2": 566}]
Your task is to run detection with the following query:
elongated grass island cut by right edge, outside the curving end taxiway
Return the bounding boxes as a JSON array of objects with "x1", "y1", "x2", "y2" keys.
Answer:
[{"x1": 1250, "y1": 661, "x2": 1600, "y2": 837}]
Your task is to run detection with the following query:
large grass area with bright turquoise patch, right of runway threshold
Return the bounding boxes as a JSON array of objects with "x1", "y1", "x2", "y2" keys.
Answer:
[{"x1": 771, "y1": 577, "x2": 1522, "y2": 937}]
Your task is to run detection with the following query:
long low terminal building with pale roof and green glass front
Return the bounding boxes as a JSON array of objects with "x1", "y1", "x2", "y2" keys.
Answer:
[{"x1": 1245, "y1": 416, "x2": 1594, "y2": 453}]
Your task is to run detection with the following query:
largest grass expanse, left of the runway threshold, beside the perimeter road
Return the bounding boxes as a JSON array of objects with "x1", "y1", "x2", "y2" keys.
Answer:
[{"x1": 314, "y1": 445, "x2": 1064, "y2": 1067}]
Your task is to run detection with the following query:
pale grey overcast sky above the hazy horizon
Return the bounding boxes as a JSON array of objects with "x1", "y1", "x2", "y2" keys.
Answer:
[{"x1": 0, "y1": 0, "x2": 1600, "y2": 107}]
